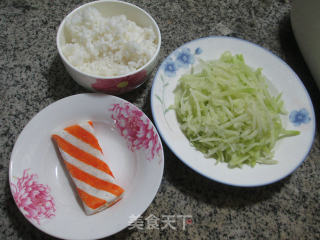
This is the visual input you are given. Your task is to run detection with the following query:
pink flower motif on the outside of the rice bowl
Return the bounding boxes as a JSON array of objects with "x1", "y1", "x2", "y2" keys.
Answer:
[{"x1": 91, "y1": 70, "x2": 147, "y2": 94}]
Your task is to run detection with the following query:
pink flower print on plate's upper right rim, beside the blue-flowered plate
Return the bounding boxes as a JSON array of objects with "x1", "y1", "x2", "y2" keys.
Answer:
[{"x1": 110, "y1": 103, "x2": 161, "y2": 160}]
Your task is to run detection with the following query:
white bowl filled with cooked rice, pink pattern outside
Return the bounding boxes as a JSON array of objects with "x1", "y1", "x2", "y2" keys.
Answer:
[{"x1": 57, "y1": 0, "x2": 161, "y2": 95}]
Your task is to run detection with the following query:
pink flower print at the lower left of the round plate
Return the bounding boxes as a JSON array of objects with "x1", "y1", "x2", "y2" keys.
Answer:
[{"x1": 11, "y1": 169, "x2": 56, "y2": 224}]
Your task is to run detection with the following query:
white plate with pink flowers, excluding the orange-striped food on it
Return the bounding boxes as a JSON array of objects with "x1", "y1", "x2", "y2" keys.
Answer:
[{"x1": 9, "y1": 93, "x2": 164, "y2": 239}]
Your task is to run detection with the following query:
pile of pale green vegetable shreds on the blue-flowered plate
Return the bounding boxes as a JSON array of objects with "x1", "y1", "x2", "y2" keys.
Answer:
[{"x1": 172, "y1": 52, "x2": 299, "y2": 168}]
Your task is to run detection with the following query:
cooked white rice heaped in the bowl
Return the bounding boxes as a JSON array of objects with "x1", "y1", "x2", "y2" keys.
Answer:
[{"x1": 61, "y1": 7, "x2": 157, "y2": 77}]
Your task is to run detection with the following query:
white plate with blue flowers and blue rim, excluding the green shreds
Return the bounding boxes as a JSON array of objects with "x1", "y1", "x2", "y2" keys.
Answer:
[{"x1": 151, "y1": 37, "x2": 315, "y2": 187}]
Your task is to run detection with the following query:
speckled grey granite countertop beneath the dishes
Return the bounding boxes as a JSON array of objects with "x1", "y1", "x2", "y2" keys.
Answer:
[{"x1": 0, "y1": 0, "x2": 320, "y2": 240}]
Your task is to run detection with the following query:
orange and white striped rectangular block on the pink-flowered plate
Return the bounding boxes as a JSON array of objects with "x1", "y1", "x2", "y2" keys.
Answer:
[{"x1": 52, "y1": 121, "x2": 124, "y2": 215}]
